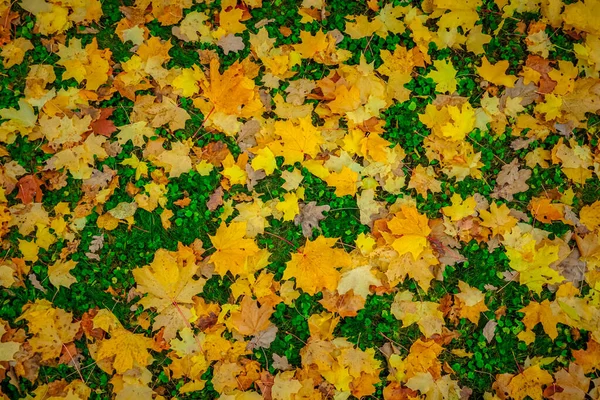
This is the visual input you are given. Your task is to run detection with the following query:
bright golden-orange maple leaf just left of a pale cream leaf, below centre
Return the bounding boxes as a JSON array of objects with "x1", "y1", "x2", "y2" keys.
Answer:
[{"x1": 283, "y1": 236, "x2": 351, "y2": 295}]
